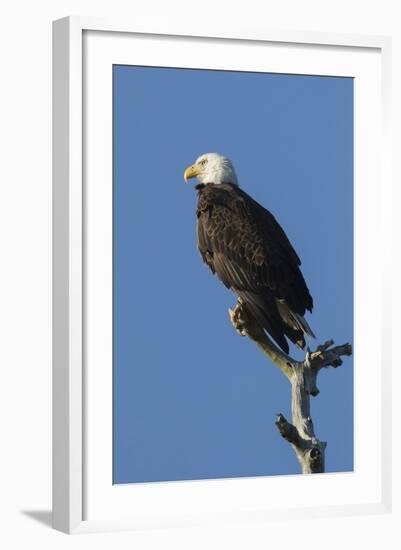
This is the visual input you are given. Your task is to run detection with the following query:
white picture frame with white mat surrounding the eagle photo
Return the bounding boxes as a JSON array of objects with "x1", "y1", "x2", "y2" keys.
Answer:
[{"x1": 53, "y1": 17, "x2": 391, "y2": 533}]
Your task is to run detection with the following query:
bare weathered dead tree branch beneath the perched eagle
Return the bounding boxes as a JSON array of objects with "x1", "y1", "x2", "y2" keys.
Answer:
[{"x1": 229, "y1": 299, "x2": 352, "y2": 474}]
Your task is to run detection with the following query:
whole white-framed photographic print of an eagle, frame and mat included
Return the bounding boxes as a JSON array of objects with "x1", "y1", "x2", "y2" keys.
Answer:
[{"x1": 53, "y1": 18, "x2": 391, "y2": 532}]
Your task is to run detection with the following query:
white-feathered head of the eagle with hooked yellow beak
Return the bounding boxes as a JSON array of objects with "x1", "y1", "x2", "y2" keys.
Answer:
[{"x1": 184, "y1": 153, "x2": 238, "y2": 185}]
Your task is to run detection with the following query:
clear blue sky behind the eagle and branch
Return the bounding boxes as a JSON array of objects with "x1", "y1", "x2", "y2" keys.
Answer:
[{"x1": 113, "y1": 66, "x2": 353, "y2": 483}]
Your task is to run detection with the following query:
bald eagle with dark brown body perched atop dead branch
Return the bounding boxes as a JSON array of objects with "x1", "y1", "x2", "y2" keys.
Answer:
[{"x1": 184, "y1": 153, "x2": 314, "y2": 353}]
